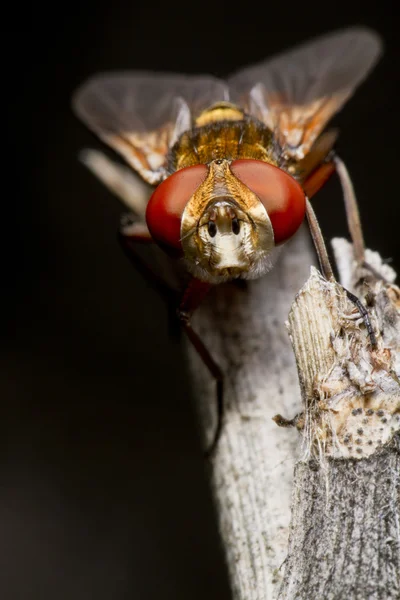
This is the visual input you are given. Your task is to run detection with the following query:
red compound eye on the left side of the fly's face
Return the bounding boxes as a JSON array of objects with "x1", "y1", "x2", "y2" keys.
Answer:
[{"x1": 146, "y1": 165, "x2": 208, "y2": 254}]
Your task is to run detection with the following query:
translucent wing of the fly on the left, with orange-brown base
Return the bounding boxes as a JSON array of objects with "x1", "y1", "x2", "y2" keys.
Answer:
[{"x1": 72, "y1": 71, "x2": 229, "y2": 184}]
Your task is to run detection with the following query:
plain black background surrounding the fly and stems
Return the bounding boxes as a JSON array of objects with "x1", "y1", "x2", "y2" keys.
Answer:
[{"x1": 0, "y1": 0, "x2": 400, "y2": 600}]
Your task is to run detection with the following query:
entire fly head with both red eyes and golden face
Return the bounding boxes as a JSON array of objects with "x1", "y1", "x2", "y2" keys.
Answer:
[{"x1": 146, "y1": 159, "x2": 305, "y2": 283}]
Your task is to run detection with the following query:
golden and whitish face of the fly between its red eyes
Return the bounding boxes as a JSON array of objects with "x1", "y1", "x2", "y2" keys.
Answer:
[{"x1": 181, "y1": 160, "x2": 274, "y2": 283}]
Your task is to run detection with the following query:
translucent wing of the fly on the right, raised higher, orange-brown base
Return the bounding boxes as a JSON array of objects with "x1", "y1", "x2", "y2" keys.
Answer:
[{"x1": 228, "y1": 27, "x2": 382, "y2": 160}]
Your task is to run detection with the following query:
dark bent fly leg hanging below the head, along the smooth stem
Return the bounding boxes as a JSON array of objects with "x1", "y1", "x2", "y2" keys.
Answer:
[{"x1": 178, "y1": 278, "x2": 224, "y2": 458}]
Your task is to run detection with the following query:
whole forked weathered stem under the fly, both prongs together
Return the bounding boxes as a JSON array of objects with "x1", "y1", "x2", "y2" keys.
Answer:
[{"x1": 186, "y1": 235, "x2": 400, "y2": 600}]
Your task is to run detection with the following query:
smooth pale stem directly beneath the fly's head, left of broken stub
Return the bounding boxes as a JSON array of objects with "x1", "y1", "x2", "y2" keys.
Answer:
[{"x1": 188, "y1": 230, "x2": 315, "y2": 600}]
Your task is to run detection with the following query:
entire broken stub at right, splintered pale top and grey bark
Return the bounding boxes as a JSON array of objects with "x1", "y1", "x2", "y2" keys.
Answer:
[{"x1": 279, "y1": 240, "x2": 400, "y2": 600}]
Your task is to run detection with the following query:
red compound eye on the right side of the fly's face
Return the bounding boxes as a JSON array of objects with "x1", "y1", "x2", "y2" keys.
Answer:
[{"x1": 231, "y1": 159, "x2": 306, "y2": 245}]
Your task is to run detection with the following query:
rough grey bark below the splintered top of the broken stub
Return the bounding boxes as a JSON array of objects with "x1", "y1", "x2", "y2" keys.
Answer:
[{"x1": 279, "y1": 443, "x2": 400, "y2": 600}]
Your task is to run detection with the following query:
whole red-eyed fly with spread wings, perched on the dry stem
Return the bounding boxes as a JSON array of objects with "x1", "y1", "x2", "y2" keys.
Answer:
[{"x1": 73, "y1": 27, "x2": 382, "y2": 450}]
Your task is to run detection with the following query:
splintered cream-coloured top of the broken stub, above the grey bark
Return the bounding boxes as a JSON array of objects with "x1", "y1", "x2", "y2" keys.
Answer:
[{"x1": 287, "y1": 240, "x2": 400, "y2": 458}]
